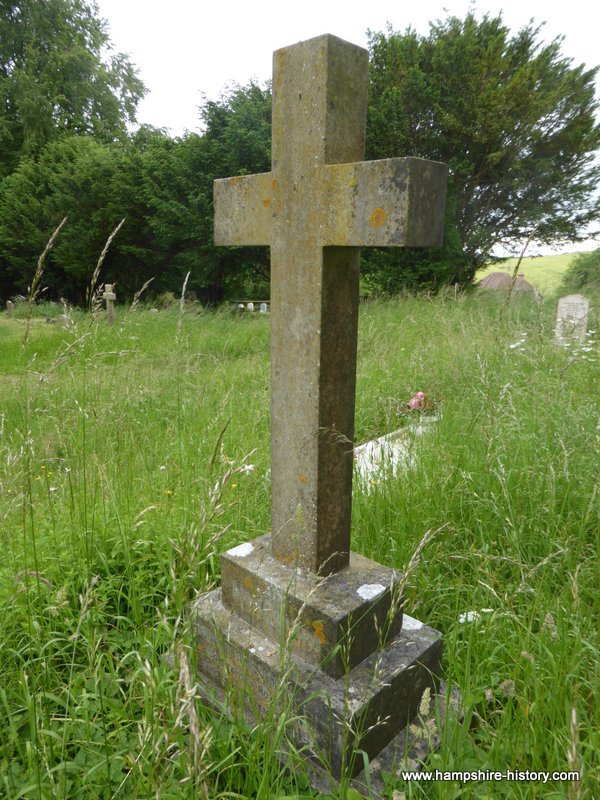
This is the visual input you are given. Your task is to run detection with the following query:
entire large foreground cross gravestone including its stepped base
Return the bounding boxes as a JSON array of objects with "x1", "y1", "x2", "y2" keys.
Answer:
[{"x1": 193, "y1": 35, "x2": 447, "y2": 785}]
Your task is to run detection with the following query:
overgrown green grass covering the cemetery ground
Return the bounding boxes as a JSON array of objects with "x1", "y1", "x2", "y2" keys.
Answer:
[{"x1": 0, "y1": 293, "x2": 600, "y2": 800}]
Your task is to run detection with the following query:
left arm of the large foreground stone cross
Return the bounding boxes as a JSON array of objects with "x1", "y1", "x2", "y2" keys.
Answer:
[{"x1": 214, "y1": 172, "x2": 277, "y2": 245}]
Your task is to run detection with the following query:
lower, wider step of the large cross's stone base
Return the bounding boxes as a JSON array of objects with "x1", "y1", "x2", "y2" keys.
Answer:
[{"x1": 193, "y1": 591, "x2": 442, "y2": 779}]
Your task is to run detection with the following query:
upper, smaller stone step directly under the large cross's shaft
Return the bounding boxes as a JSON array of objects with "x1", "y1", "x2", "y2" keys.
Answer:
[{"x1": 221, "y1": 536, "x2": 402, "y2": 678}]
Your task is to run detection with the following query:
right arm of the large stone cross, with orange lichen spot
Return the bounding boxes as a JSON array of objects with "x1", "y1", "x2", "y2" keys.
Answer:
[{"x1": 321, "y1": 157, "x2": 448, "y2": 247}]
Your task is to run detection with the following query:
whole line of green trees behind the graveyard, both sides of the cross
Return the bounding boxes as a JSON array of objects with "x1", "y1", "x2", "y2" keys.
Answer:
[{"x1": 0, "y1": 9, "x2": 600, "y2": 303}]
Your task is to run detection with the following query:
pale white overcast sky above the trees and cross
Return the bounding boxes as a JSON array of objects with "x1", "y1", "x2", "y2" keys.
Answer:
[{"x1": 97, "y1": 0, "x2": 600, "y2": 136}]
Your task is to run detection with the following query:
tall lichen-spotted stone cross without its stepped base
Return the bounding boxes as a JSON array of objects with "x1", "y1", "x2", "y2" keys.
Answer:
[{"x1": 214, "y1": 35, "x2": 447, "y2": 574}]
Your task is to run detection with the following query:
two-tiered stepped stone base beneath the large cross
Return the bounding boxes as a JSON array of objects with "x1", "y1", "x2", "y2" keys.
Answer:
[{"x1": 192, "y1": 537, "x2": 442, "y2": 786}]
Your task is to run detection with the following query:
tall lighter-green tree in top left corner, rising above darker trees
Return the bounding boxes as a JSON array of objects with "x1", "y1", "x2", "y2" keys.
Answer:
[{"x1": 0, "y1": 0, "x2": 145, "y2": 177}]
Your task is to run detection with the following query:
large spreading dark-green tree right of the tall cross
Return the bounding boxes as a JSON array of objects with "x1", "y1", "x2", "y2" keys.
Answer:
[{"x1": 365, "y1": 13, "x2": 600, "y2": 288}]
